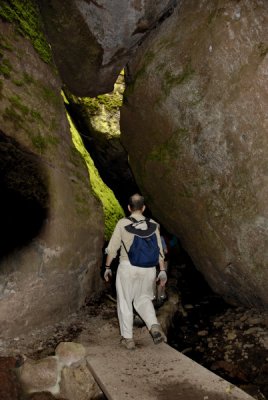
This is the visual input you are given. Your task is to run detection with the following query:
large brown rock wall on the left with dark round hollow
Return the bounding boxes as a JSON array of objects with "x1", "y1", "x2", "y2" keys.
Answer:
[{"x1": 0, "y1": 17, "x2": 103, "y2": 338}]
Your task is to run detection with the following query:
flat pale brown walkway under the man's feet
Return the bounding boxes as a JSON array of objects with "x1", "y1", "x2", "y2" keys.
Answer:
[{"x1": 87, "y1": 329, "x2": 254, "y2": 400}]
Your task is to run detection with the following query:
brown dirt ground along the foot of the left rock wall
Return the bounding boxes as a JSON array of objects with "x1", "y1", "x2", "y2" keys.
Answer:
[{"x1": 0, "y1": 290, "x2": 117, "y2": 400}]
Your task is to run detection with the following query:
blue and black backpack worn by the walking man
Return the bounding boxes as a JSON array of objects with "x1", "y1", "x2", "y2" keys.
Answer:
[{"x1": 122, "y1": 217, "x2": 160, "y2": 267}]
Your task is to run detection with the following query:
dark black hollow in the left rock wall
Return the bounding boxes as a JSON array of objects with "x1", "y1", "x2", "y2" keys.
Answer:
[{"x1": 0, "y1": 130, "x2": 49, "y2": 261}]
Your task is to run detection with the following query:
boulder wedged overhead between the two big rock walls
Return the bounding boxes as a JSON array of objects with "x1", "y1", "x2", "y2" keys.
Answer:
[{"x1": 38, "y1": 0, "x2": 177, "y2": 96}]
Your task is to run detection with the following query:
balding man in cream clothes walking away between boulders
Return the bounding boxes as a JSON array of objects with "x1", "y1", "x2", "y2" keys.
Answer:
[{"x1": 104, "y1": 194, "x2": 167, "y2": 350}]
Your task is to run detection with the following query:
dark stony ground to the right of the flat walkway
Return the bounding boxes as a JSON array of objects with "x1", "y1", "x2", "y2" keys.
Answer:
[{"x1": 168, "y1": 263, "x2": 268, "y2": 400}]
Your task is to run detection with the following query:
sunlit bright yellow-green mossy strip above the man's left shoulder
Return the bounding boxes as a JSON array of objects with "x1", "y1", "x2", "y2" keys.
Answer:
[{"x1": 68, "y1": 111, "x2": 124, "y2": 240}]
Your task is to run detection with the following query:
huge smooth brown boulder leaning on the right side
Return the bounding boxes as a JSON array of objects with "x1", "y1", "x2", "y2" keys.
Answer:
[{"x1": 121, "y1": 0, "x2": 268, "y2": 308}]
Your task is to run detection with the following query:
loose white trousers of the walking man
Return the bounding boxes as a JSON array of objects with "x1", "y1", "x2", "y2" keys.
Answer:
[{"x1": 116, "y1": 261, "x2": 158, "y2": 339}]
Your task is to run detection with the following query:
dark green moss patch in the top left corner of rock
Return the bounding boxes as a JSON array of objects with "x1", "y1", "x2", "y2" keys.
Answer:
[{"x1": 0, "y1": 0, "x2": 52, "y2": 63}]
